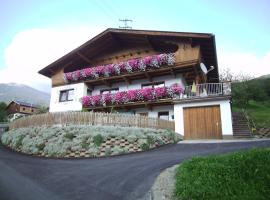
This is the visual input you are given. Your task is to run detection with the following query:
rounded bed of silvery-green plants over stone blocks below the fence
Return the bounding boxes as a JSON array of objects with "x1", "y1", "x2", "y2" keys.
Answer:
[{"x1": 1, "y1": 125, "x2": 179, "y2": 158}]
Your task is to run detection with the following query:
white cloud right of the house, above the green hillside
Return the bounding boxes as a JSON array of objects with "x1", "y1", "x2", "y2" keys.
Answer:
[{"x1": 218, "y1": 51, "x2": 270, "y2": 77}]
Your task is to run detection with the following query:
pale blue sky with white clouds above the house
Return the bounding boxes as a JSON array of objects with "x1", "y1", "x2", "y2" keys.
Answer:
[{"x1": 0, "y1": 0, "x2": 270, "y2": 92}]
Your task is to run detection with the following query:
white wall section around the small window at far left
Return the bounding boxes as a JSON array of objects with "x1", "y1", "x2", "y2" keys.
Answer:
[{"x1": 50, "y1": 83, "x2": 87, "y2": 112}]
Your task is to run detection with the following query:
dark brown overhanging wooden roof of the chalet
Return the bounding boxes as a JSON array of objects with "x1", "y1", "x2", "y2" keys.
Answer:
[{"x1": 39, "y1": 28, "x2": 218, "y2": 79}]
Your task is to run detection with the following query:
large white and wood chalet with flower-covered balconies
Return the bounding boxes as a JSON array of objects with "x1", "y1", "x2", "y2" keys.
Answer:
[{"x1": 39, "y1": 29, "x2": 232, "y2": 139}]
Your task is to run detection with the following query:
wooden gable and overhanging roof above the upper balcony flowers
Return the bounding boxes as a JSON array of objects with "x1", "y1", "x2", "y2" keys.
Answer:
[{"x1": 39, "y1": 29, "x2": 218, "y2": 82}]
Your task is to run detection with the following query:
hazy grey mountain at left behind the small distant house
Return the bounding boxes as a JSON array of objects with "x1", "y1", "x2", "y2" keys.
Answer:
[{"x1": 0, "y1": 83, "x2": 50, "y2": 106}]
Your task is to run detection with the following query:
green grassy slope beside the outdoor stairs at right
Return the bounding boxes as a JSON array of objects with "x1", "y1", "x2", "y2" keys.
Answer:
[{"x1": 232, "y1": 101, "x2": 270, "y2": 128}]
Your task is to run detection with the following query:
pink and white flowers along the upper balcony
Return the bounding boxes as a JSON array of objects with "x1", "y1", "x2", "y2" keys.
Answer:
[{"x1": 64, "y1": 53, "x2": 175, "y2": 83}]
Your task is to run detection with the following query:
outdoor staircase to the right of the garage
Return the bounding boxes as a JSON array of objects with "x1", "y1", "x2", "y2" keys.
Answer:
[{"x1": 232, "y1": 113, "x2": 251, "y2": 138}]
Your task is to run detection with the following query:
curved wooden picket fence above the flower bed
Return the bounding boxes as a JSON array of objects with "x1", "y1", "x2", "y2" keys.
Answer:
[{"x1": 9, "y1": 112, "x2": 174, "y2": 131}]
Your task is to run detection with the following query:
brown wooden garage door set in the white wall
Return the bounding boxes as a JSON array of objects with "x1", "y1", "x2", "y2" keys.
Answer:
[{"x1": 184, "y1": 106, "x2": 222, "y2": 139}]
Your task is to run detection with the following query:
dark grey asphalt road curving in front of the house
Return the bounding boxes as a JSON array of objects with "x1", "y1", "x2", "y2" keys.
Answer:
[{"x1": 0, "y1": 140, "x2": 270, "y2": 200}]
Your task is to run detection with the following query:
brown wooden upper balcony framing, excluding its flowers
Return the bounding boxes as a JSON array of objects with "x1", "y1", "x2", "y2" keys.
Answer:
[{"x1": 52, "y1": 43, "x2": 211, "y2": 87}]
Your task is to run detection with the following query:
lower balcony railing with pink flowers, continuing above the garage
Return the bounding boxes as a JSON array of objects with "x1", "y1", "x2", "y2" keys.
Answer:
[{"x1": 82, "y1": 82, "x2": 231, "y2": 110}]
